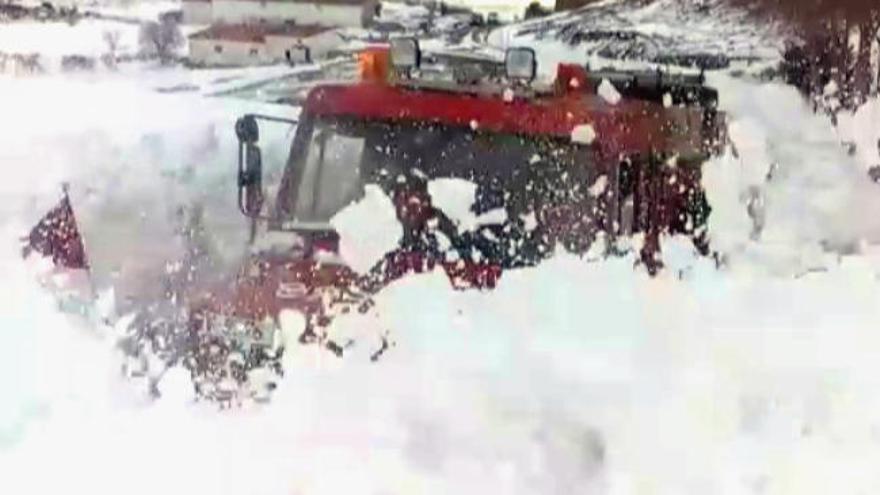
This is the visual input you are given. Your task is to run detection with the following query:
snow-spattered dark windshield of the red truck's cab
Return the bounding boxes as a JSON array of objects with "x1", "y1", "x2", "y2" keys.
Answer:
[{"x1": 277, "y1": 118, "x2": 594, "y2": 228}]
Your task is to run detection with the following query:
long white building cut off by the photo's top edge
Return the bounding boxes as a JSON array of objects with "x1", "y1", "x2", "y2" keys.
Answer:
[{"x1": 183, "y1": 0, "x2": 378, "y2": 27}]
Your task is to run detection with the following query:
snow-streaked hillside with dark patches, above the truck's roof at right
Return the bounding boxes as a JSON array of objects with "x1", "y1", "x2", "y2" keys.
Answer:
[{"x1": 487, "y1": 0, "x2": 783, "y2": 81}]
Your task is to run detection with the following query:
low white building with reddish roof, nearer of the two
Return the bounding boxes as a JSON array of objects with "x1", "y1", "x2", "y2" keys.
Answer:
[{"x1": 189, "y1": 24, "x2": 342, "y2": 66}]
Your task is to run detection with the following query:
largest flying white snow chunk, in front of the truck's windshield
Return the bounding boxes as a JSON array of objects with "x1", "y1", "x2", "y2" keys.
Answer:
[{"x1": 330, "y1": 184, "x2": 403, "y2": 273}]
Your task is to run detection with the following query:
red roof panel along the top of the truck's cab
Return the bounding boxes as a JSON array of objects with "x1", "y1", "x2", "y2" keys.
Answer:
[{"x1": 303, "y1": 82, "x2": 687, "y2": 154}]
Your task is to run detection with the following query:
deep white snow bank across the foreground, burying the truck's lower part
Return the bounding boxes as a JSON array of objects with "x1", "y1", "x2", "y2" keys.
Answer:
[{"x1": 0, "y1": 252, "x2": 880, "y2": 494}]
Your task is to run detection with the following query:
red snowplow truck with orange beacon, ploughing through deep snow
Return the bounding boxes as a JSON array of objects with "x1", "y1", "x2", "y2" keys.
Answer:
[{"x1": 31, "y1": 39, "x2": 724, "y2": 397}]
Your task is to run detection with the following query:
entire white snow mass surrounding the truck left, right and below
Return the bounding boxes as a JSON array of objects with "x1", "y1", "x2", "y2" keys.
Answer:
[{"x1": 0, "y1": 3, "x2": 880, "y2": 495}]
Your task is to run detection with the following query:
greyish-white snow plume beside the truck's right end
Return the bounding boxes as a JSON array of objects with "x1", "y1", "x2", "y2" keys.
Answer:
[{"x1": 703, "y1": 75, "x2": 880, "y2": 275}]
